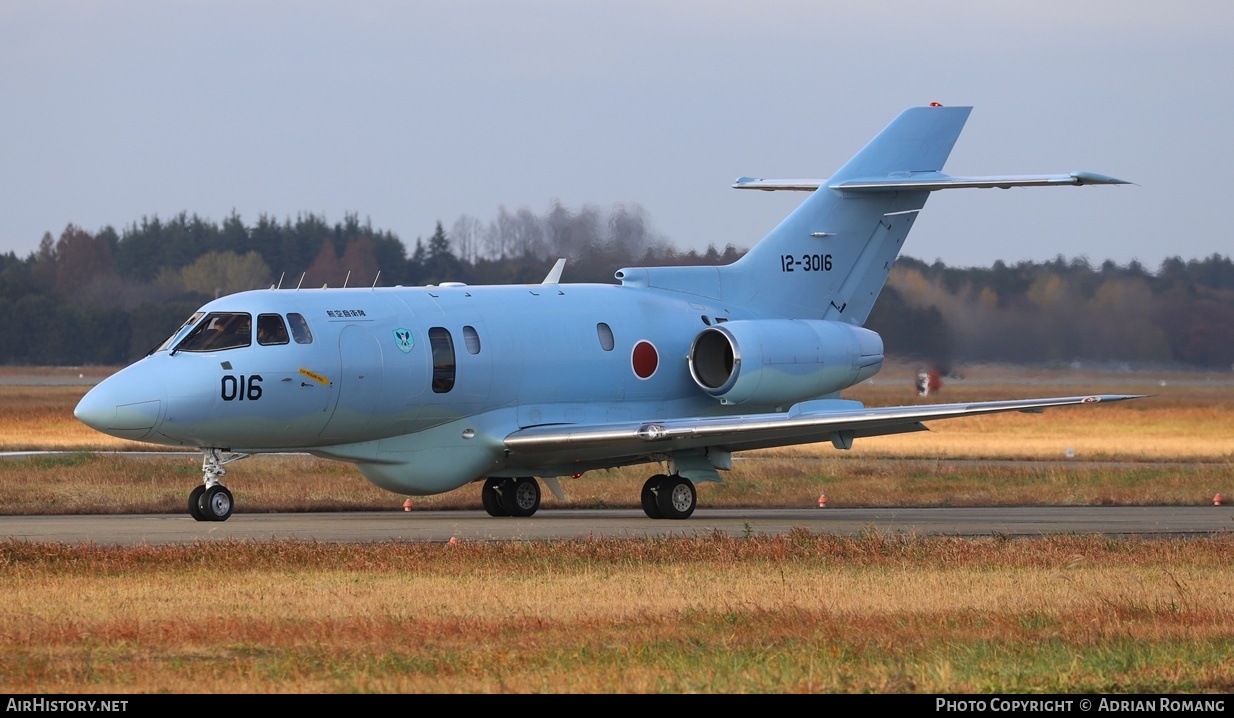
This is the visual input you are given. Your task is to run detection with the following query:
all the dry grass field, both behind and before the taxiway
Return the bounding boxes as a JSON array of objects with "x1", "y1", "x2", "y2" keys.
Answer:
[{"x1": 0, "y1": 368, "x2": 1234, "y2": 693}]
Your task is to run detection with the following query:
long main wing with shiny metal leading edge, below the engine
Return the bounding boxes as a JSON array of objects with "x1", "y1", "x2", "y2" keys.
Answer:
[{"x1": 505, "y1": 394, "x2": 1143, "y2": 458}]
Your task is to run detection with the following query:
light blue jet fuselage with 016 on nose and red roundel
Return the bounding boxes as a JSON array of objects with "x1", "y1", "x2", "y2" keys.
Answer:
[{"x1": 75, "y1": 284, "x2": 878, "y2": 492}]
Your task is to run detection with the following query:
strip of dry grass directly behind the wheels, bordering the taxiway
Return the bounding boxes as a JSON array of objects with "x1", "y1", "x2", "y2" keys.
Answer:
[{"x1": 0, "y1": 453, "x2": 1234, "y2": 514}]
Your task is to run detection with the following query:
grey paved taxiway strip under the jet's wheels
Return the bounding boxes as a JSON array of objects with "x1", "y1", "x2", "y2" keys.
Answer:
[{"x1": 0, "y1": 506, "x2": 1234, "y2": 545}]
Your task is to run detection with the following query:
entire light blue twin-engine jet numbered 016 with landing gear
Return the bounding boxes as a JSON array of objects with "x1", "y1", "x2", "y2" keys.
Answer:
[{"x1": 74, "y1": 105, "x2": 1130, "y2": 521}]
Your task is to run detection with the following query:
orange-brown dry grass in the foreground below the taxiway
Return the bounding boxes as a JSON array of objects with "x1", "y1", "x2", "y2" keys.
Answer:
[{"x1": 0, "y1": 537, "x2": 1234, "y2": 693}]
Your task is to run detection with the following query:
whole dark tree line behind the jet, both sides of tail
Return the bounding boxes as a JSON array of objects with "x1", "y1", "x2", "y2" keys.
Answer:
[{"x1": 0, "y1": 202, "x2": 1234, "y2": 369}]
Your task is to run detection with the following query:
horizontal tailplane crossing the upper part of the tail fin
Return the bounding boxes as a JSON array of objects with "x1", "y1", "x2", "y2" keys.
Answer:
[{"x1": 733, "y1": 171, "x2": 1132, "y2": 192}]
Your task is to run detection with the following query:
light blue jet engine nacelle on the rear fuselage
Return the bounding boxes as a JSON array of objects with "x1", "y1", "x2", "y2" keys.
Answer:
[{"x1": 690, "y1": 320, "x2": 882, "y2": 407}]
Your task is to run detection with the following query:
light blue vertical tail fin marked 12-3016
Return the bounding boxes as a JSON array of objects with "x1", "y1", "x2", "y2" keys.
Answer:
[{"x1": 719, "y1": 106, "x2": 972, "y2": 326}]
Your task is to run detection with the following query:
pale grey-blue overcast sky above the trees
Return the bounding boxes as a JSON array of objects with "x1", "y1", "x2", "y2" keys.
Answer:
[{"x1": 0, "y1": 0, "x2": 1234, "y2": 271}]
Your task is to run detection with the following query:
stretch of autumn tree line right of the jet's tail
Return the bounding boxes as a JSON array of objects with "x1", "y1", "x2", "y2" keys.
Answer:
[{"x1": 870, "y1": 254, "x2": 1234, "y2": 370}]
